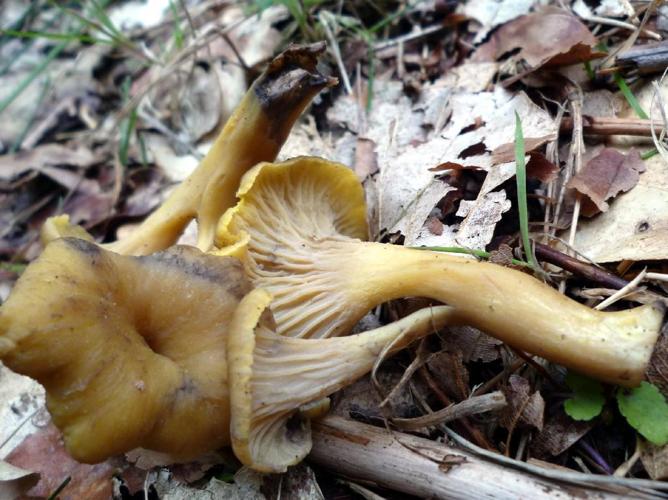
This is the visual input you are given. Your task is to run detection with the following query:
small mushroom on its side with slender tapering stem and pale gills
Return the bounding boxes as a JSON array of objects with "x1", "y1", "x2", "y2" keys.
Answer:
[{"x1": 227, "y1": 289, "x2": 457, "y2": 472}]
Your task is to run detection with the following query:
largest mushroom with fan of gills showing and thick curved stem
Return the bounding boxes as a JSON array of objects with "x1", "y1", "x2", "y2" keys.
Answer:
[{"x1": 217, "y1": 157, "x2": 663, "y2": 386}]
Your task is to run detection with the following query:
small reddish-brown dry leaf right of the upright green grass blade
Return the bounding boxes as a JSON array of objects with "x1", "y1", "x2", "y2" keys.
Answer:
[{"x1": 567, "y1": 148, "x2": 645, "y2": 216}]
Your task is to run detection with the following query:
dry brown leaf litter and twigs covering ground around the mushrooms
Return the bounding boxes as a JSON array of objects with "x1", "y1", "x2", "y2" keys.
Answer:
[{"x1": 0, "y1": 1, "x2": 668, "y2": 498}]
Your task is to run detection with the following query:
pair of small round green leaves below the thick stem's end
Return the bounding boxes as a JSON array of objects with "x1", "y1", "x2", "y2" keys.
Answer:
[{"x1": 564, "y1": 372, "x2": 668, "y2": 446}]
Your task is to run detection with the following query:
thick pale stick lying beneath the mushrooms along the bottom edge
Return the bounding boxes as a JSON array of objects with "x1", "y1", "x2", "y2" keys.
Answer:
[{"x1": 309, "y1": 417, "x2": 647, "y2": 499}]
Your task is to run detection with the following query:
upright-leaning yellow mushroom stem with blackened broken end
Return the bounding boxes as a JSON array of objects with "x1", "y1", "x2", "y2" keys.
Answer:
[{"x1": 107, "y1": 43, "x2": 336, "y2": 255}]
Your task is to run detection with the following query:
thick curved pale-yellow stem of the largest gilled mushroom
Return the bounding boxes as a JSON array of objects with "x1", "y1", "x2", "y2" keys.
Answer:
[{"x1": 337, "y1": 242, "x2": 663, "y2": 386}]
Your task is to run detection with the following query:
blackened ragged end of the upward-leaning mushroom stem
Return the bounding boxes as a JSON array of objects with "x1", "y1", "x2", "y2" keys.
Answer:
[{"x1": 253, "y1": 42, "x2": 338, "y2": 142}]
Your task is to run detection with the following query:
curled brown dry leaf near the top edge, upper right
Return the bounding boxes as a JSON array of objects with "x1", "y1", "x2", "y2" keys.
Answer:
[{"x1": 471, "y1": 7, "x2": 599, "y2": 70}]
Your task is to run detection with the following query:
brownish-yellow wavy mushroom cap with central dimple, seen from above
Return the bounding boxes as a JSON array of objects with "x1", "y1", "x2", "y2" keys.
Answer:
[{"x1": 0, "y1": 238, "x2": 250, "y2": 462}]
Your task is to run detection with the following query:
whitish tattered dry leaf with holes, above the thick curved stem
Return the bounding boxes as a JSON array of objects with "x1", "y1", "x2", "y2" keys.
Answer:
[{"x1": 377, "y1": 88, "x2": 556, "y2": 242}]
